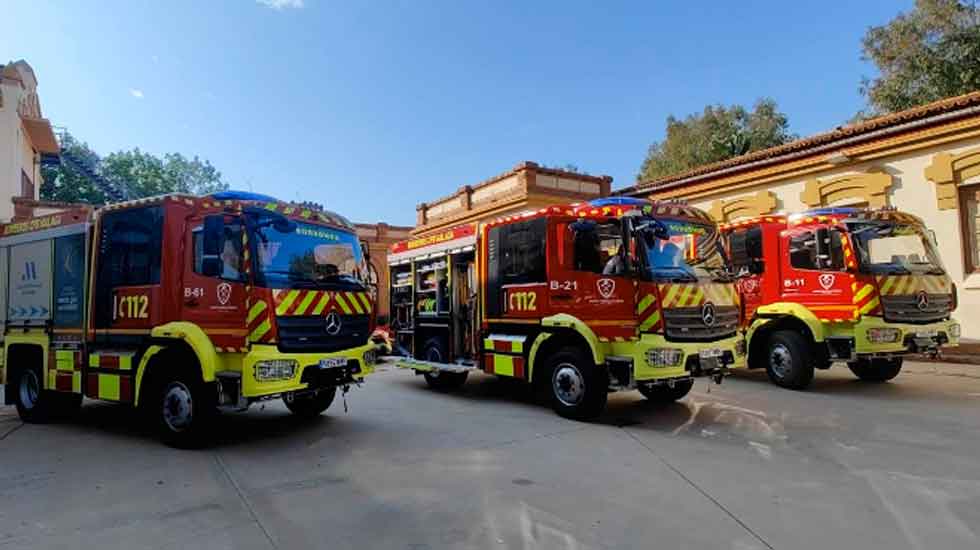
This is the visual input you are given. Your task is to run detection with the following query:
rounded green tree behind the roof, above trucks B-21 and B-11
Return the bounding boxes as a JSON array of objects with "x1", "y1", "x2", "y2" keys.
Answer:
[{"x1": 637, "y1": 98, "x2": 795, "y2": 181}]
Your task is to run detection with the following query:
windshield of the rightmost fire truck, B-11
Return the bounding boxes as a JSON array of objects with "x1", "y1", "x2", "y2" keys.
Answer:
[{"x1": 847, "y1": 222, "x2": 945, "y2": 275}]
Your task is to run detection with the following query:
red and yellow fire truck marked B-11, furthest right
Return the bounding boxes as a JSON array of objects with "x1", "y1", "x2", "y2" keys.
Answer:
[{"x1": 722, "y1": 208, "x2": 960, "y2": 389}]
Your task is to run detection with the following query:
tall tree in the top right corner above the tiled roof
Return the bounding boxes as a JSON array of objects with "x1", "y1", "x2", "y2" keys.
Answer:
[{"x1": 861, "y1": 0, "x2": 980, "y2": 114}]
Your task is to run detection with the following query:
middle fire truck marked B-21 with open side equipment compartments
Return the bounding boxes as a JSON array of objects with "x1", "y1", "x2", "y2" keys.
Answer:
[{"x1": 388, "y1": 198, "x2": 745, "y2": 419}]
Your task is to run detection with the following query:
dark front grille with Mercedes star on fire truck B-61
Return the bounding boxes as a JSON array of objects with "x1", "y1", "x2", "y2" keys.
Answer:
[{"x1": 276, "y1": 315, "x2": 371, "y2": 352}]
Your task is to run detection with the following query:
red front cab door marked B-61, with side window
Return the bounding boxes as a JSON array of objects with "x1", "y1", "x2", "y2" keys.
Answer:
[{"x1": 180, "y1": 214, "x2": 247, "y2": 350}]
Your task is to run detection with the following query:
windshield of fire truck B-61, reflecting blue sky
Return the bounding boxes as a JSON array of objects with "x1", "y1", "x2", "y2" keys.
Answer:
[{"x1": 255, "y1": 223, "x2": 363, "y2": 290}]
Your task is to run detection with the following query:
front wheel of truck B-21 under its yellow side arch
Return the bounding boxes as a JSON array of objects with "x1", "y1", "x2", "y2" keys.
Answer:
[{"x1": 545, "y1": 347, "x2": 609, "y2": 420}]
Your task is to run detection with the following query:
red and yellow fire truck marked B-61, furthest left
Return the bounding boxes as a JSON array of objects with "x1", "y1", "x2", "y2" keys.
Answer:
[{"x1": 0, "y1": 192, "x2": 376, "y2": 446}]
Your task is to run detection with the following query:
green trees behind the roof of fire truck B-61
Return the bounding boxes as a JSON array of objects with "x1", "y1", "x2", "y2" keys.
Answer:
[{"x1": 41, "y1": 133, "x2": 228, "y2": 204}]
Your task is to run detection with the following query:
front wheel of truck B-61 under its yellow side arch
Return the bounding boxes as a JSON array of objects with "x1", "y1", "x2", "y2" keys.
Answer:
[{"x1": 148, "y1": 367, "x2": 217, "y2": 449}]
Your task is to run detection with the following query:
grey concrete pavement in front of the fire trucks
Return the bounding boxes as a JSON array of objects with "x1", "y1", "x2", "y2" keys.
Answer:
[{"x1": 0, "y1": 363, "x2": 980, "y2": 550}]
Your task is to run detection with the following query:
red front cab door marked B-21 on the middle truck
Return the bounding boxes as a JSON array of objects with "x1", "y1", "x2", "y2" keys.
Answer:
[{"x1": 548, "y1": 219, "x2": 636, "y2": 338}]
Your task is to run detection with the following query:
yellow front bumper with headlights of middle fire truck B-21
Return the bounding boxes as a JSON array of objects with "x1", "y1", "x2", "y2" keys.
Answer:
[{"x1": 606, "y1": 334, "x2": 746, "y2": 383}]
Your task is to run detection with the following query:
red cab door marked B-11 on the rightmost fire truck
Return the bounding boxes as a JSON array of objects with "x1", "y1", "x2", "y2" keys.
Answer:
[{"x1": 779, "y1": 227, "x2": 853, "y2": 319}]
